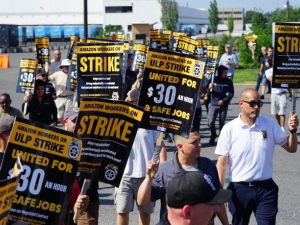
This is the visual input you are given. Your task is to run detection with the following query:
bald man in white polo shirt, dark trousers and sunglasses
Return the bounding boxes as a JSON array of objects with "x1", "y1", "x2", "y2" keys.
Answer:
[{"x1": 215, "y1": 88, "x2": 299, "y2": 225}]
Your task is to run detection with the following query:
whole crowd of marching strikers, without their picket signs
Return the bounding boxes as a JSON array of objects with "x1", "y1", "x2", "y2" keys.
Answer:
[{"x1": 0, "y1": 45, "x2": 299, "y2": 225}]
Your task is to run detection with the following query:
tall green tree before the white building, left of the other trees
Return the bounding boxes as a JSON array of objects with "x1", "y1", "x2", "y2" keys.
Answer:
[{"x1": 158, "y1": 0, "x2": 178, "y2": 31}]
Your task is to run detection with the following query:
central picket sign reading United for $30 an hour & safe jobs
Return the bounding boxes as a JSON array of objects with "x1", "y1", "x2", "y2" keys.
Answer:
[{"x1": 138, "y1": 48, "x2": 205, "y2": 136}]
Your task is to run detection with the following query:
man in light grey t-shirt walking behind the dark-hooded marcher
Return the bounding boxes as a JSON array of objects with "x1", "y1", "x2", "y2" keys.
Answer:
[{"x1": 219, "y1": 44, "x2": 238, "y2": 81}]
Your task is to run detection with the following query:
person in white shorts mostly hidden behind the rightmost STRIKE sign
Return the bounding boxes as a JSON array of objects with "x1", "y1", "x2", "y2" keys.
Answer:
[{"x1": 265, "y1": 60, "x2": 292, "y2": 131}]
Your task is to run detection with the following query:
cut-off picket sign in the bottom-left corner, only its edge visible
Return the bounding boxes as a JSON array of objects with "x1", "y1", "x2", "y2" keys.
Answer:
[{"x1": 0, "y1": 159, "x2": 23, "y2": 224}]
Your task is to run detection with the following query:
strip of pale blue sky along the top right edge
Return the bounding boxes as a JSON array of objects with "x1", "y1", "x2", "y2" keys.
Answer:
[{"x1": 176, "y1": 0, "x2": 300, "y2": 13}]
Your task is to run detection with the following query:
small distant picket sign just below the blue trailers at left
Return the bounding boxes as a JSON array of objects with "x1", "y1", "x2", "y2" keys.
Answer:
[{"x1": 35, "y1": 37, "x2": 50, "y2": 64}]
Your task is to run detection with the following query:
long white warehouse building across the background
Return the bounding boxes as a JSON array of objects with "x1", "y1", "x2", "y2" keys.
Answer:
[{"x1": 0, "y1": 0, "x2": 209, "y2": 39}]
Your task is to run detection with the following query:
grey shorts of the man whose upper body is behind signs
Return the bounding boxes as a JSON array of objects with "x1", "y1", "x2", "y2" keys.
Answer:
[{"x1": 115, "y1": 177, "x2": 154, "y2": 214}]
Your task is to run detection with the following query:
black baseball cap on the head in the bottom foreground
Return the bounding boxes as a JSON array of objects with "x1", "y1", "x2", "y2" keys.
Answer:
[{"x1": 167, "y1": 171, "x2": 232, "y2": 208}]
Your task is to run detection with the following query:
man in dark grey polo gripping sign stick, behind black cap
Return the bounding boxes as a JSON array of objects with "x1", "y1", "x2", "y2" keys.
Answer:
[{"x1": 137, "y1": 128, "x2": 229, "y2": 224}]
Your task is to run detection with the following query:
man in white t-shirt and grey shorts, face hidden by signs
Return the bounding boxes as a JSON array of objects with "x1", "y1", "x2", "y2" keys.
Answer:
[{"x1": 115, "y1": 89, "x2": 166, "y2": 225}]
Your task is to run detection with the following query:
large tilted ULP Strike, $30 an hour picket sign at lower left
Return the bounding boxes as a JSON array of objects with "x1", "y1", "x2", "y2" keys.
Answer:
[{"x1": 0, "y1": 117, "x2": 81, "y2": 225}]
